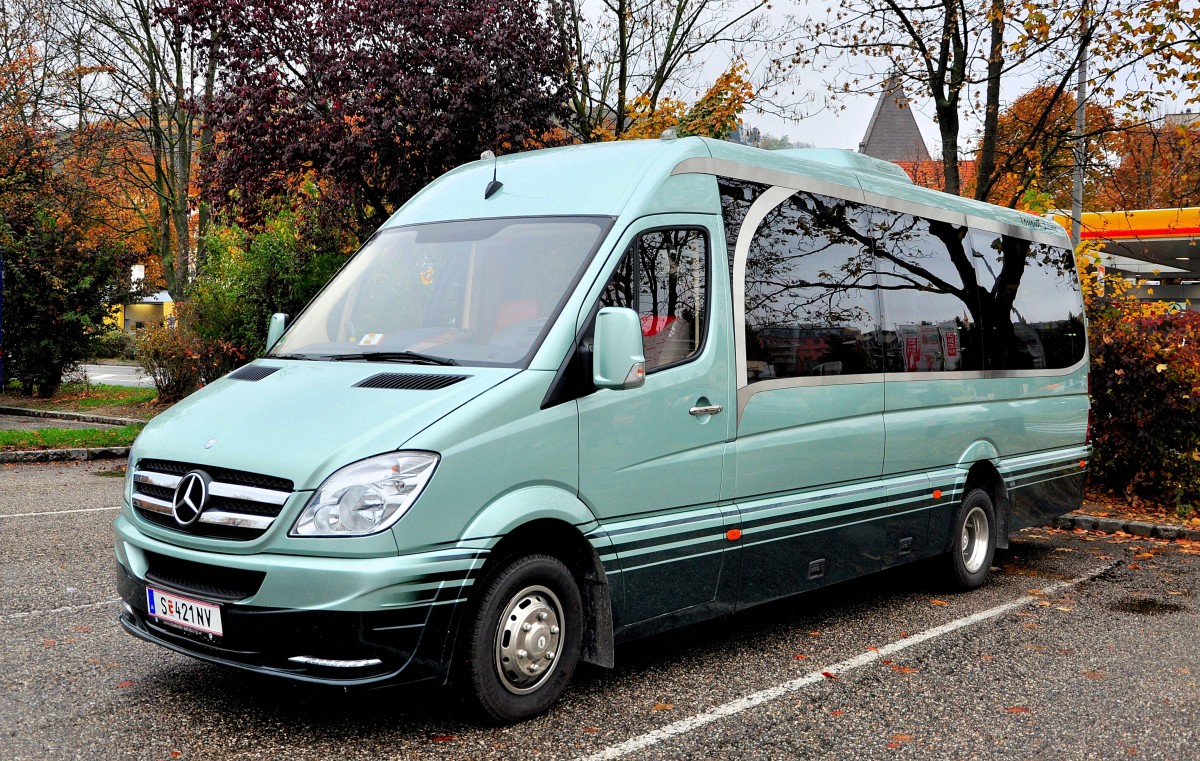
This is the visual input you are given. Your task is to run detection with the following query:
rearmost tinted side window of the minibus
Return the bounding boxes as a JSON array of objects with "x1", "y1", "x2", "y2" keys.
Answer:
[{"x1": 971, "y1": 230, "x2": 1086, "y2": 370}]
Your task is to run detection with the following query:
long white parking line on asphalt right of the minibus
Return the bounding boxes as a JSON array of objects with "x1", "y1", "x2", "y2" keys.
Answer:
[{"x1": 581, "y1": 563, "x2": 1116, "y2": 761}]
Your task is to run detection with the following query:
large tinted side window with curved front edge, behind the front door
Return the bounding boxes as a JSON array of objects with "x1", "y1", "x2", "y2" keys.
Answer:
[{"x1": 745, "y1": 192, "x2": 882, "y2": 382}]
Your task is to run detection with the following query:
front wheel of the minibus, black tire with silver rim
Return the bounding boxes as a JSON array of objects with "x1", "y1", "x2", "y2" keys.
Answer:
[{"x1": 460, "y1": 555, "x2": 583, "y2": 724}]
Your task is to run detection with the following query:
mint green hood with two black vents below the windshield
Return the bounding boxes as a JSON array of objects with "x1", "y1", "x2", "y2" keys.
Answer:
[{"x1": 131, "y1": 360, "x2": 520, "y2": 490}]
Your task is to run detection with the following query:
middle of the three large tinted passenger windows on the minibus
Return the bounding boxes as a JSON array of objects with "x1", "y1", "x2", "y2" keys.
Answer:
[{"x1": 875, "y1": 209, "x2": 983, "y2": 372}]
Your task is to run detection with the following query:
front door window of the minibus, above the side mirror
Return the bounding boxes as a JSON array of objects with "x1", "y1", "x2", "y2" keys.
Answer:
[{"x1": 600, "y1": 229, "x2": 708, "y2": 372}]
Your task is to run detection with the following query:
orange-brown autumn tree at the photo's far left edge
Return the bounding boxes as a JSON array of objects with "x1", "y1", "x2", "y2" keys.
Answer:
[{"x1": 0, "y1": 31, "x2": 139, "y2": 396}]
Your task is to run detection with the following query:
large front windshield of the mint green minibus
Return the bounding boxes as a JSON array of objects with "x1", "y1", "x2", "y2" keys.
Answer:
[{"x1": 270, "y1": 217, "x2": 612, "y2": 366}]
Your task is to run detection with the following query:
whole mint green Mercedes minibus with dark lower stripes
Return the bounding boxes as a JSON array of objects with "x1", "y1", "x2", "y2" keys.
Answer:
[{"x1": 115, "y1": 138, "x2": 1090, "y2": 721}]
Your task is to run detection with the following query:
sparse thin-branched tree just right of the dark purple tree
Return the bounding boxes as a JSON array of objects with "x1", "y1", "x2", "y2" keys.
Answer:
[{"x1": 550, "y1": 0, "x2": 797, "y2": 140}]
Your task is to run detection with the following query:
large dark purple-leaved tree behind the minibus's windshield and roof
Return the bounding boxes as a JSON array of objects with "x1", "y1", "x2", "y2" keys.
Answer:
[{"x1": 178, "y1": 0, "x2": 564, "y2": 232}]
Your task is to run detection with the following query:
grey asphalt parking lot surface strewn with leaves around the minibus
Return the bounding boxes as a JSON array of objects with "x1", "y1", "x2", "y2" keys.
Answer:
[{"x1": 0, "y1": 461, "x2": 1200, "y2": 761}]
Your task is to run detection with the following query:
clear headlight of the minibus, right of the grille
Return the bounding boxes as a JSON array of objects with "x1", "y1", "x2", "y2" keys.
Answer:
[{"x1": 290, "y1": 451, "x2": 438, "y2": 537}]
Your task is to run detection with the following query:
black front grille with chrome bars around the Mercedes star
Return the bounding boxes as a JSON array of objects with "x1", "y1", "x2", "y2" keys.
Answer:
[{"x1": 133, "y1": 460, "x2": 293, "y2": 541}]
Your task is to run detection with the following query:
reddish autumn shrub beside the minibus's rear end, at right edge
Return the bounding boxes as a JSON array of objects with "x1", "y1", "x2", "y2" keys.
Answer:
[{"x1": 1091, "y1": 311, "x2": 1200, "y2": 513}]
